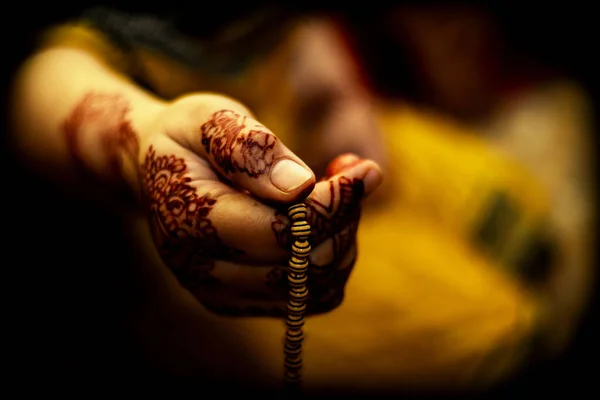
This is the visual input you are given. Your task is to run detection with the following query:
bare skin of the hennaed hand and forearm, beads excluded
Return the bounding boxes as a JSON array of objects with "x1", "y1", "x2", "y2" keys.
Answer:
[{"x1": 12, "y1": 48, "x2": 382, "y2": 316}]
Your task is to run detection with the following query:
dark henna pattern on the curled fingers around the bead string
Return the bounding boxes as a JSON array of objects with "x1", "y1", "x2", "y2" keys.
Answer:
[{"x1": 267, "y1": 176, "x2": 364, "y2": 314}]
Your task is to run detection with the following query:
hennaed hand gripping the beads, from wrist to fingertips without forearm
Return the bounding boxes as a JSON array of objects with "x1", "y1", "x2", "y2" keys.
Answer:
[{"x1": 68, "y1": 95, "x2": 382, "y2": 316}]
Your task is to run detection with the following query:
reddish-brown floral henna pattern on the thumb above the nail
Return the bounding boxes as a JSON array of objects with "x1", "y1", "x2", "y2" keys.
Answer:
[{"x1": 200, "y1": 110, "x2": 278, "y2": 178}]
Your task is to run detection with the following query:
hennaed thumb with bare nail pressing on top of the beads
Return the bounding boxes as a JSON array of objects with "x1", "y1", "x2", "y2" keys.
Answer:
[{"x1": 162, "y1": 95, "x2": 316, "y2": 203}]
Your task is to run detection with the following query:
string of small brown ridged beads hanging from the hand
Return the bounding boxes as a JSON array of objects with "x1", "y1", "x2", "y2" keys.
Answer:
[{"x1": 284, "y1": 203, "x2": 311, "y2": 387}]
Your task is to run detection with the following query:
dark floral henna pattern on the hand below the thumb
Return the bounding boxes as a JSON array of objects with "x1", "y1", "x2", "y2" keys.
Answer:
[{"x1": 140, "y1": 146, "x2": 242, "y2": 292}]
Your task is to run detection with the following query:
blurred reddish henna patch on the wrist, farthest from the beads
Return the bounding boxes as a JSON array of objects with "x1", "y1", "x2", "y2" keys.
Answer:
[{"x1": 62, "y1": 93, "x2": 139, "y2": 177}]
